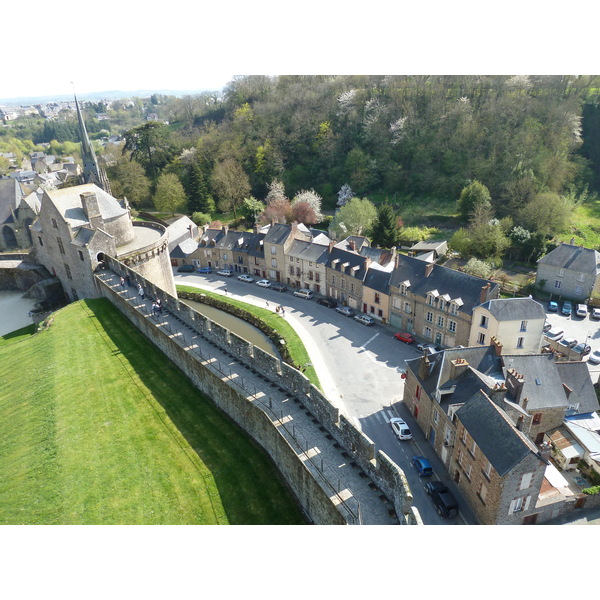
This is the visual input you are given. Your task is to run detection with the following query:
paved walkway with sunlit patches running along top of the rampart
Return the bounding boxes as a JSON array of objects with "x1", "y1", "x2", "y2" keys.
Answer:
[{"x1": 98, "y1": 271, "x2": 398, "y2": 525}]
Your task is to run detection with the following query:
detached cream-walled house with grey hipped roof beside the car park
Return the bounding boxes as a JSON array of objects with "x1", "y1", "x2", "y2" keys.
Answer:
[{"x1": 468, "y1": 298, "x2": 546, "y2": 354}]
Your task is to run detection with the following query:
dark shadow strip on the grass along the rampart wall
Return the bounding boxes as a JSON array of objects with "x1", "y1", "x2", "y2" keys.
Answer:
[{"x1": 86, "y1": 299, "x2": 306, "y2": 525}]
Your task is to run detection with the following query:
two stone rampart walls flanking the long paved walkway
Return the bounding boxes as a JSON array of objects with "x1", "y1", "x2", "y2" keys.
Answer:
[{"x1": 98, "y1": 258, "x2": 419, "y2": 524}]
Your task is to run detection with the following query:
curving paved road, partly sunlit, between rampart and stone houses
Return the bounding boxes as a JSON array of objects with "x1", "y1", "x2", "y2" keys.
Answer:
[{"x1": 174, "y1": 272, "x2": 473, "y2": 524}]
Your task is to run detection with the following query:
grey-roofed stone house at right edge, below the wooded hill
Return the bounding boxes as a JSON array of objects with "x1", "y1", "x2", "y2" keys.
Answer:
[{"x1": 535, "y1": 243, "x2": 600, "y2": 302}]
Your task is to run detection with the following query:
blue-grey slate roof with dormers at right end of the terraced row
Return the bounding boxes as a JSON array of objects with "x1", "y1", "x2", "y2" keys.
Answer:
[{"x1": 390, "y1": 255, "x2": 499, "y2": 314}]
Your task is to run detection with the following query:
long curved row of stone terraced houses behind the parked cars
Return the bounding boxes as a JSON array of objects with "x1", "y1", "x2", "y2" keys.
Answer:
[{"x1": 171, "y1": 223, "x2": 502, "y2": 350}]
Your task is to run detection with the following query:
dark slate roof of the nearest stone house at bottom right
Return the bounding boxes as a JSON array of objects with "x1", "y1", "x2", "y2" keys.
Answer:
[{"x1": 455, "y1": 391, "x2": 536, "y2": 477}]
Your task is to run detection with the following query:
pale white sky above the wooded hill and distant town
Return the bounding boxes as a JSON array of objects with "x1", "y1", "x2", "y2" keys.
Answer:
[{"x1": 0, "y1": 0, "x2": 599, "y2": 98}]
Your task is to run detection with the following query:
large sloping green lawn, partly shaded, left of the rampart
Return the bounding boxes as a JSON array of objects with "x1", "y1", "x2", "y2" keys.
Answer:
[{"x1": 0, "y1": 300, "x2": 303, "y2": 524}]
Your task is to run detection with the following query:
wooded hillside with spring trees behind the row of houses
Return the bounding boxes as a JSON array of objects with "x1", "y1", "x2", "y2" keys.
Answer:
[{"x1": 0, "y1": 75, "x2": 600, "y2": 270}]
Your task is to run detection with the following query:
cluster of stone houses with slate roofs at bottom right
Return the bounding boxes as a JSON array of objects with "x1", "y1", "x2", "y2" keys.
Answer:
[{"x1": 404, "y1": 338, "x2": 598, "y2": 524}]
